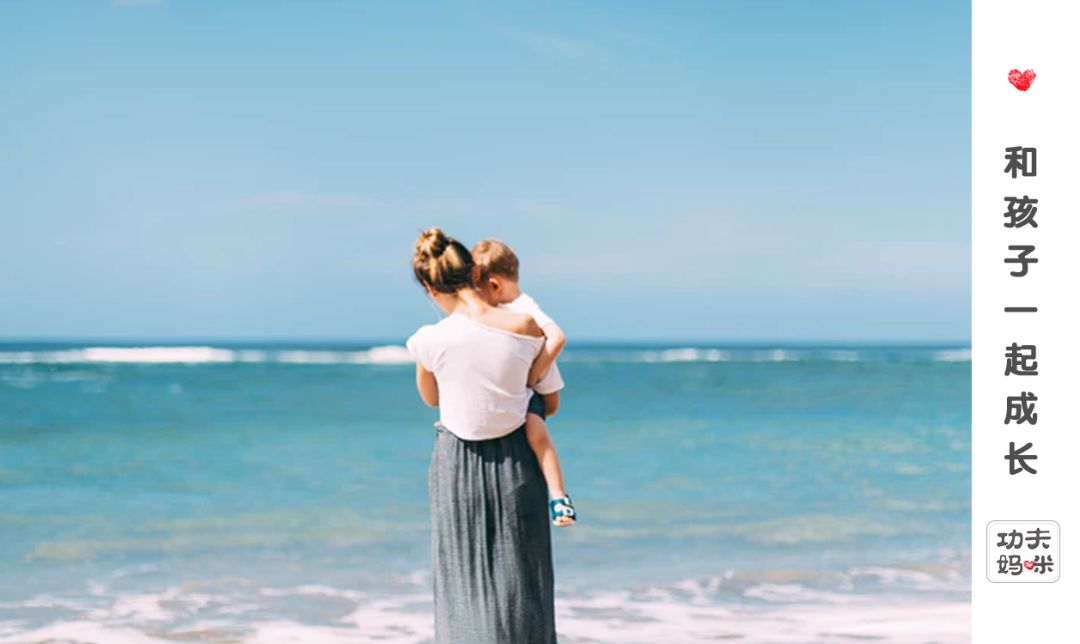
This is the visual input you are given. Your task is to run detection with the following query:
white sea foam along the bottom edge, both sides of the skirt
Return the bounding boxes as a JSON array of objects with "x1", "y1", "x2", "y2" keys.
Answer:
[{"x1": 0, "y1": 590, "x2": 971, "y2": 644}]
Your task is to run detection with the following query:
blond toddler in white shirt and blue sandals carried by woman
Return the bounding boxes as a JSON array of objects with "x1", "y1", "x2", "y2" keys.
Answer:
[{"x1": 472, "y1": 239, "x2": 577, "y2": 527}]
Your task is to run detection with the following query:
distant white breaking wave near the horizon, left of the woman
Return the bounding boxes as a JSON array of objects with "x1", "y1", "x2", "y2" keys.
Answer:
[{"x1": 0, "y1": 345, "x2": 413, "y2": 364}]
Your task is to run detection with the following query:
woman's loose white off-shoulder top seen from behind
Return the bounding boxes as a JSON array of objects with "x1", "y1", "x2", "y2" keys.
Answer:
[{"x1": 405, "y1": 313, "x2": 563, "y2": 441}]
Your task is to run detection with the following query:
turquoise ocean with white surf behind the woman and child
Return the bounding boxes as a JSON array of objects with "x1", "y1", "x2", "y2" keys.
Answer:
[{"x1": 0, "y1": 343, "x2": 971, "y2": 643}]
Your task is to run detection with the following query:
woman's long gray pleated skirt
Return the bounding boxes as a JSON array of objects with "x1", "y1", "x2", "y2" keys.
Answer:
[{"x1": 428, "y1": 426, "x2": 555, "y2": 644}]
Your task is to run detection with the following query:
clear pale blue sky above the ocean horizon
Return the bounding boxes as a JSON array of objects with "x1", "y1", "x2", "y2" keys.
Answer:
[{"x1": 0, "y1": 0, "x2": 971, "y2": 341}]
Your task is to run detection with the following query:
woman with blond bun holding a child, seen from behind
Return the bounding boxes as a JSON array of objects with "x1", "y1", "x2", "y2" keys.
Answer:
[{"x1": 406, "y1": 228, "x2": 561, "y2": 644}]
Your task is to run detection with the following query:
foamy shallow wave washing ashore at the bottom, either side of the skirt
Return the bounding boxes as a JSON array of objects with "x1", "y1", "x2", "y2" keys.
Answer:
[{"x1": 0, "y1": 568, "x2": 971, "y2": 643}]
